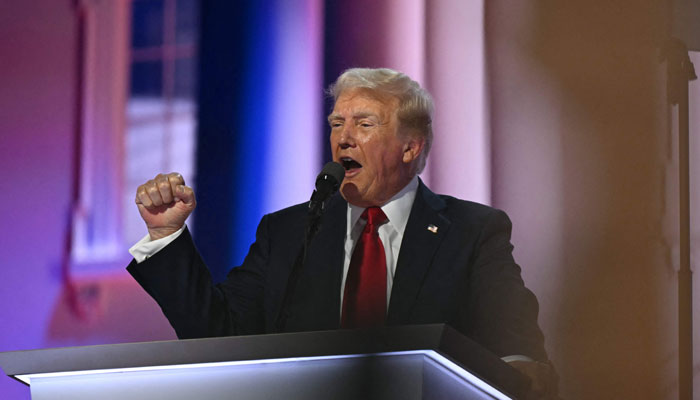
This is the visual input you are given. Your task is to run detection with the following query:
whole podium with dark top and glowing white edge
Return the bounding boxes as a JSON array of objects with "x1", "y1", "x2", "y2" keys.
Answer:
[{"x1": 0, "y1": 324, "x2": 529, "y2": 400}]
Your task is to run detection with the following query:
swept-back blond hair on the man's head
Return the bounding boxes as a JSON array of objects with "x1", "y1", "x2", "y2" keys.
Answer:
[{"x1": 328, "y1": 68, "x2": 434, "y2": 173}]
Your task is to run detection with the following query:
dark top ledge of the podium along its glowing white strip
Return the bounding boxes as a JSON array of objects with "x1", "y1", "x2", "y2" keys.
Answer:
[{"x1": 0, "y1": 324, "x2": 529, "y2": 398}]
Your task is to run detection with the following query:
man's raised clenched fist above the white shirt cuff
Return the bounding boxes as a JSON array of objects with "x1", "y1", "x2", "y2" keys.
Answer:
[{"x1": 136, "y1": 172, "x2": 197, "y2": 240}]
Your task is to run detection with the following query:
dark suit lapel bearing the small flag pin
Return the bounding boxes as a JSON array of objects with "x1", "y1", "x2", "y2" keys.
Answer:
[{"x1": 387, "y1": 181, "x2": 450, "y2": 325}]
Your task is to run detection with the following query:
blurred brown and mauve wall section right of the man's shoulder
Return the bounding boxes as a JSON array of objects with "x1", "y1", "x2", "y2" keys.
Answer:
[{"x1": 486, "y1": 1, "x2": 678, "y2": 399}]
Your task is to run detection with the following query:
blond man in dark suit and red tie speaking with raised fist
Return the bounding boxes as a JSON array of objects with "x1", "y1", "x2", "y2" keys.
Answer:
[{"x1": 128, "y1": 69, "x2": 551, "y2": 394}]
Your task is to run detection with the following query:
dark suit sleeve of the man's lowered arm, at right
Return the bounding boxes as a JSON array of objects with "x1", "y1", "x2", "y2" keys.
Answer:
[{"x1": 468, "y1": 209, "x2": 547, "y2": 361}]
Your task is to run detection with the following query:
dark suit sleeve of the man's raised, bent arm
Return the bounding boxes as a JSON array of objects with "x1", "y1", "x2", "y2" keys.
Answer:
[{"x1": 127, "y1": 216, "x2": 269, "y2": 339}]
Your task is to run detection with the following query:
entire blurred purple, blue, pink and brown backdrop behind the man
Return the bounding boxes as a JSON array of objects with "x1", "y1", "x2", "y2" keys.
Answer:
[{"x1": 0, "y1": 0, "x2": 700, "y2": 399}]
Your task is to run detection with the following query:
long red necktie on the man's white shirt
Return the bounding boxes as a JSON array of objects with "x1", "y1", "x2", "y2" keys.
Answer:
[{"x1": 340, "y1": 207, "x2": 387, "y2": 328}]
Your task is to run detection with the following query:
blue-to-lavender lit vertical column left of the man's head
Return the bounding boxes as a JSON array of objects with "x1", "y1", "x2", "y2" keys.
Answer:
[{"x1": 262, "y1": 0, "x2": 324, "y2": 213}]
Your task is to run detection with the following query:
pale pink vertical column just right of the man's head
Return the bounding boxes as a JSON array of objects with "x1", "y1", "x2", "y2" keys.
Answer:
[{"x1": 425, "y1": 0, "x2": 491, "y2": 204}]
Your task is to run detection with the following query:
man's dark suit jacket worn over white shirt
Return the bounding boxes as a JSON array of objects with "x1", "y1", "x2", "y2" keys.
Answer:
[{"x1": 127, "y1": 182, "x2": 547, "y2": 361}]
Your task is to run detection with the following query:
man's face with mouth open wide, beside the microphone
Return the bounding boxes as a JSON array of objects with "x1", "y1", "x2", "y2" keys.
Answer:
[{"x1": 328, "y1": 89, "x2": 423, "y2": 207}]
